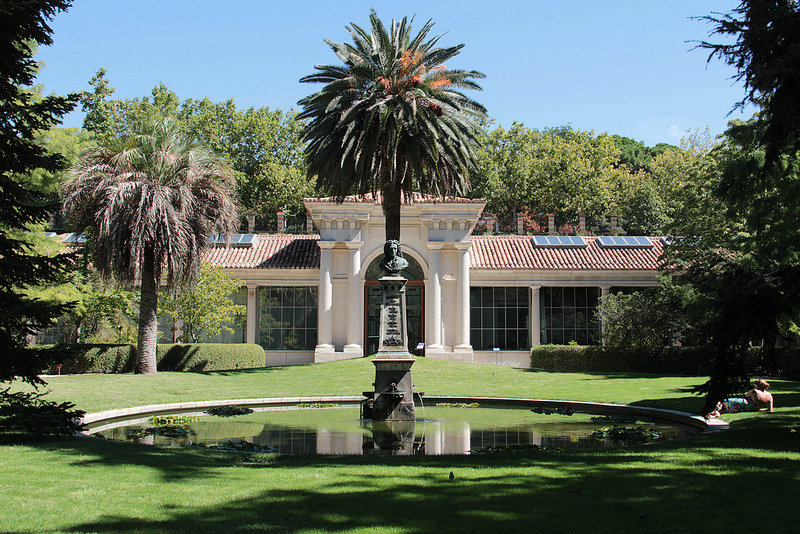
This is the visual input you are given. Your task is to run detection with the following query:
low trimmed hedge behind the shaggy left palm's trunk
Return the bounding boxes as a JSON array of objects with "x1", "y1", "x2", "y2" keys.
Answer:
[{"x1": 38, "y1": 343, "x2": 265, "y2": 374}]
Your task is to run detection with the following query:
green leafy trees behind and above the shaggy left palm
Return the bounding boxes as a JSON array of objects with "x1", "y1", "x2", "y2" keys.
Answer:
[{"x1": 83, "y1": 69, "x2": 313, "y2": 227}]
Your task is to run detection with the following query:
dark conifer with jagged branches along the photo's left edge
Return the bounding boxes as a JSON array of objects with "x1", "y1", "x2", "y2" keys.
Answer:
[{"x1": 0, "y1": 0, "x2": 78, "y2": 384}]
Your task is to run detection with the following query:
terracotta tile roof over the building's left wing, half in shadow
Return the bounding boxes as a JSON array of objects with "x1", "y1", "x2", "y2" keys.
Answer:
[{"x1": 203, "y1": 234, "x2": 319, "y2": 269}]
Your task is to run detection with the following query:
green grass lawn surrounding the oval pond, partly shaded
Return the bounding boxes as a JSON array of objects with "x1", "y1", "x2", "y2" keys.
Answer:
[{"x1": 0, "y1": 359, "x2": 800, "y2": 533}]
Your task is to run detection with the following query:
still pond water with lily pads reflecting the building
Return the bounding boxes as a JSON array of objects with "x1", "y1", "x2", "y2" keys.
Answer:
[{"x1": 89, "y1": 405, "x2": 696, "y2": 455}]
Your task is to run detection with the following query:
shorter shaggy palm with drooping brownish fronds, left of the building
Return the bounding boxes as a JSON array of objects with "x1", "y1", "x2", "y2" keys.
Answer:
[{"x1": 64, "y1": 117, "x2": 238, "y2": 374}]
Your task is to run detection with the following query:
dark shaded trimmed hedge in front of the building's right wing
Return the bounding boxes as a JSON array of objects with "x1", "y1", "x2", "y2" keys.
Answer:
[{"x1": 531, "y1": 345, "x2": 800, "y2": 378}]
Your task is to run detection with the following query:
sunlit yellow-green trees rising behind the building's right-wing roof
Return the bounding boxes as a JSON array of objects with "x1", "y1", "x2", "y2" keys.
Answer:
[{"x1": 472, "y1": 123, "x2": 682, "y2": 235}]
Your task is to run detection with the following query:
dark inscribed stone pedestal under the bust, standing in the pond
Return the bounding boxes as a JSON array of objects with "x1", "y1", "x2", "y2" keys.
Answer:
[{"x1": 372, "y1": 275, "x2": 415, "y2": 421}]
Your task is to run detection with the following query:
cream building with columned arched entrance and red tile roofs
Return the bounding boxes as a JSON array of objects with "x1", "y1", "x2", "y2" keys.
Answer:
[{"x1": 195, "y1": 195, "x2": 662, "y2": 366}]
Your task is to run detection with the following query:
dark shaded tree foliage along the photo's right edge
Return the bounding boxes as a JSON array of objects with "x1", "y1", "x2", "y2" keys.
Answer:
[{"x1": 667, "y1": 0, "x2": 800, "y2": 407}]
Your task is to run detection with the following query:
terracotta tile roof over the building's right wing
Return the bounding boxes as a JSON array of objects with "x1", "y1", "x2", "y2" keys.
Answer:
[{"x1": 470, "y1": 235, "x2": 662, "y2": 271}]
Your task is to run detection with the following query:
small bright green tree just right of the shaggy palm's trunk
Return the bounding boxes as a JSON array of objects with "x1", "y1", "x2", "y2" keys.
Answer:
[{"x1": 161, "y1": 263, "x2": 247, "y2": 343}]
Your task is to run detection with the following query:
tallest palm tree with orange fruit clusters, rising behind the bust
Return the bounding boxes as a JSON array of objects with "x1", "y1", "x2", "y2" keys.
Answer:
[{"x1": 299, "y1": 11, "x2": 486, "y2": 247}]
